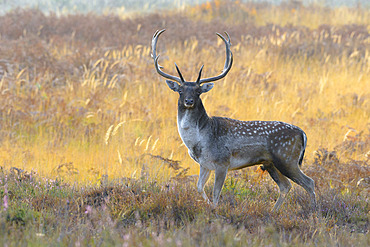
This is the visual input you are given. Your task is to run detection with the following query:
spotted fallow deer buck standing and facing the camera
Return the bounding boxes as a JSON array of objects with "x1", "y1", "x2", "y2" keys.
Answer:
[{"x1": 151, "y1": 29, "x2": 316, "y2": 212}]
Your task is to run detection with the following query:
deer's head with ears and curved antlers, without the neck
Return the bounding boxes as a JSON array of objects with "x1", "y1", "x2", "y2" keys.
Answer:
[{"x1": 152, "y1": 29, "x2": 233, "y2": 109}]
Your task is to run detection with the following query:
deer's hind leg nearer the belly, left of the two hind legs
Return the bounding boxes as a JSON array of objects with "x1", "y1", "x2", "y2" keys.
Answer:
[{"x1": 263, "y1": 164, "x2": 292, "y2": 212}]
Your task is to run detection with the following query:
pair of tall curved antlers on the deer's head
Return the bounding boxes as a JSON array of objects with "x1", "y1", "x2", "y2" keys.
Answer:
[{"x1": 151, "y1": 29, "x2": 233, "y2": 84}]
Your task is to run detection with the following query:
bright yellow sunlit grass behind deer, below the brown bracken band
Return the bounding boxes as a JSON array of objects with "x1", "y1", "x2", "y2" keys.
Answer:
[{"x1": 0, "y1": 17, "x2": 369, "y2": 182}]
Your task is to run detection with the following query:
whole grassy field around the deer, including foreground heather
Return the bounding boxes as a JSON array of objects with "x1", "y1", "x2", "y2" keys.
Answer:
[{"x1": 0, "y1": 0, "x2": 370, "y2": 246}]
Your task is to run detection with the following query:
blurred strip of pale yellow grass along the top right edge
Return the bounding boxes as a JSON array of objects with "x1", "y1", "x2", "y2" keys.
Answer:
[{"x1": 185, "y1": 0, "x2": 370, "y2": 29}]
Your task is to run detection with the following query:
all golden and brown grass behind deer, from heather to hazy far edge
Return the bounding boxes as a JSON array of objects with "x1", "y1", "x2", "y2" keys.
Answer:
[{"x1": 0, "y1": 1, "x2": 370, "y2": 184}]
